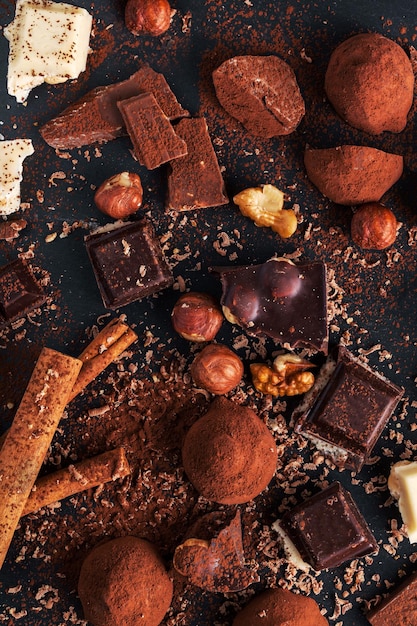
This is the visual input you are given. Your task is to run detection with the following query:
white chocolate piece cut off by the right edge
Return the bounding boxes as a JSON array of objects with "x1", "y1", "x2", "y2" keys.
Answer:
[{"x1": 388, "y1": 461, "x2": 417, "y2": 543}]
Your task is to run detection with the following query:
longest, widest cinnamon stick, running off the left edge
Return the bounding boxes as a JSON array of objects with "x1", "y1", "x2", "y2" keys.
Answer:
[{"x1": 0, "y1": 348, "x2": 82, "y2": 568}]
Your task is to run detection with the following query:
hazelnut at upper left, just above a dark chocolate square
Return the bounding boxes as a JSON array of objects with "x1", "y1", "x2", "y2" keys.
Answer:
[{"x1": 94, "y1": 172, "x2": 143, "y2": 220}]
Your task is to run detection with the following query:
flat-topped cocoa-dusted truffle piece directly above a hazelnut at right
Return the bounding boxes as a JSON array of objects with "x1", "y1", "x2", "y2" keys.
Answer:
[{"x1": 304, "y1": 146, "x2": 403, "y2": 205}]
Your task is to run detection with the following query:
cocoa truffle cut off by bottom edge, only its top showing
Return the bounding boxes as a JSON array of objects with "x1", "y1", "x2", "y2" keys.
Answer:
[{"x1": 233, "y1": 589, "x2": 328, "y2": 626}]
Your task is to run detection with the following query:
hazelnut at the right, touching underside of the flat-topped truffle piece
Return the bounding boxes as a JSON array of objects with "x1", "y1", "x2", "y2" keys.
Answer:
[{"x1": 351, "y1": 202, "x2": 398, "y2": 250}]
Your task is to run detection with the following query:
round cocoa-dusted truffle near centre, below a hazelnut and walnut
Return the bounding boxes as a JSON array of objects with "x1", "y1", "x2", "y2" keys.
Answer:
[{"x1": 182, "y1": 397, "x2": 278, "y2": 504}]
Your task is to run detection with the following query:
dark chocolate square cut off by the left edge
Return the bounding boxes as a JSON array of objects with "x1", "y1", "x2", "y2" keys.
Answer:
[{"x1": 0, "y1": 259, "x2": 46, "y2": 327}]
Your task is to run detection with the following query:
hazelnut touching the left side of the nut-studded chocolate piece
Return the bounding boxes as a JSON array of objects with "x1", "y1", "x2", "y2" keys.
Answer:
[{"x1": 171, "y1": 291, "x2": 223, "y2": 342}]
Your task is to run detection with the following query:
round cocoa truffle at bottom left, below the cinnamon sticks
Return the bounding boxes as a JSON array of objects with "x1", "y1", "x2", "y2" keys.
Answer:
[{"x1": 78, "y1": 537, "x2": 173, "y2": 626}]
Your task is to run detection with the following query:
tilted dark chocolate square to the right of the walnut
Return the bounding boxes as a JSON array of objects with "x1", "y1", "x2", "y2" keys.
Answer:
[{"x1": 292, "y1": 346, "x2": 403, "y2": 471}]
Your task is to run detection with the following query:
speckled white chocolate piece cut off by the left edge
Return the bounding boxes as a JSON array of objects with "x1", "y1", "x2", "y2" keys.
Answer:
[{"x1": 0, "y1": 139, "x2": 34, "y2": 215}]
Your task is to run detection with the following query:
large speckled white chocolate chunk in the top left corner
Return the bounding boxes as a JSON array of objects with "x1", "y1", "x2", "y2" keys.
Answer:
[{"x1": 4, "y1": 0, "x2": 92, "y2": 102}]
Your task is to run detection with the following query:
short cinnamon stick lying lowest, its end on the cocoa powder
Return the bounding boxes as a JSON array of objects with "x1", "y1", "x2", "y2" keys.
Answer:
[{"x1": 22, "y1": 448, "x2": 130, "y2": 515}]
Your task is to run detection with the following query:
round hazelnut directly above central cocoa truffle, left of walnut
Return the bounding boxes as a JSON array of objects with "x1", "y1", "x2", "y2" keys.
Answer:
[{"x1": 191, "y1": 343, "x2": 243, "y2": 396}]
